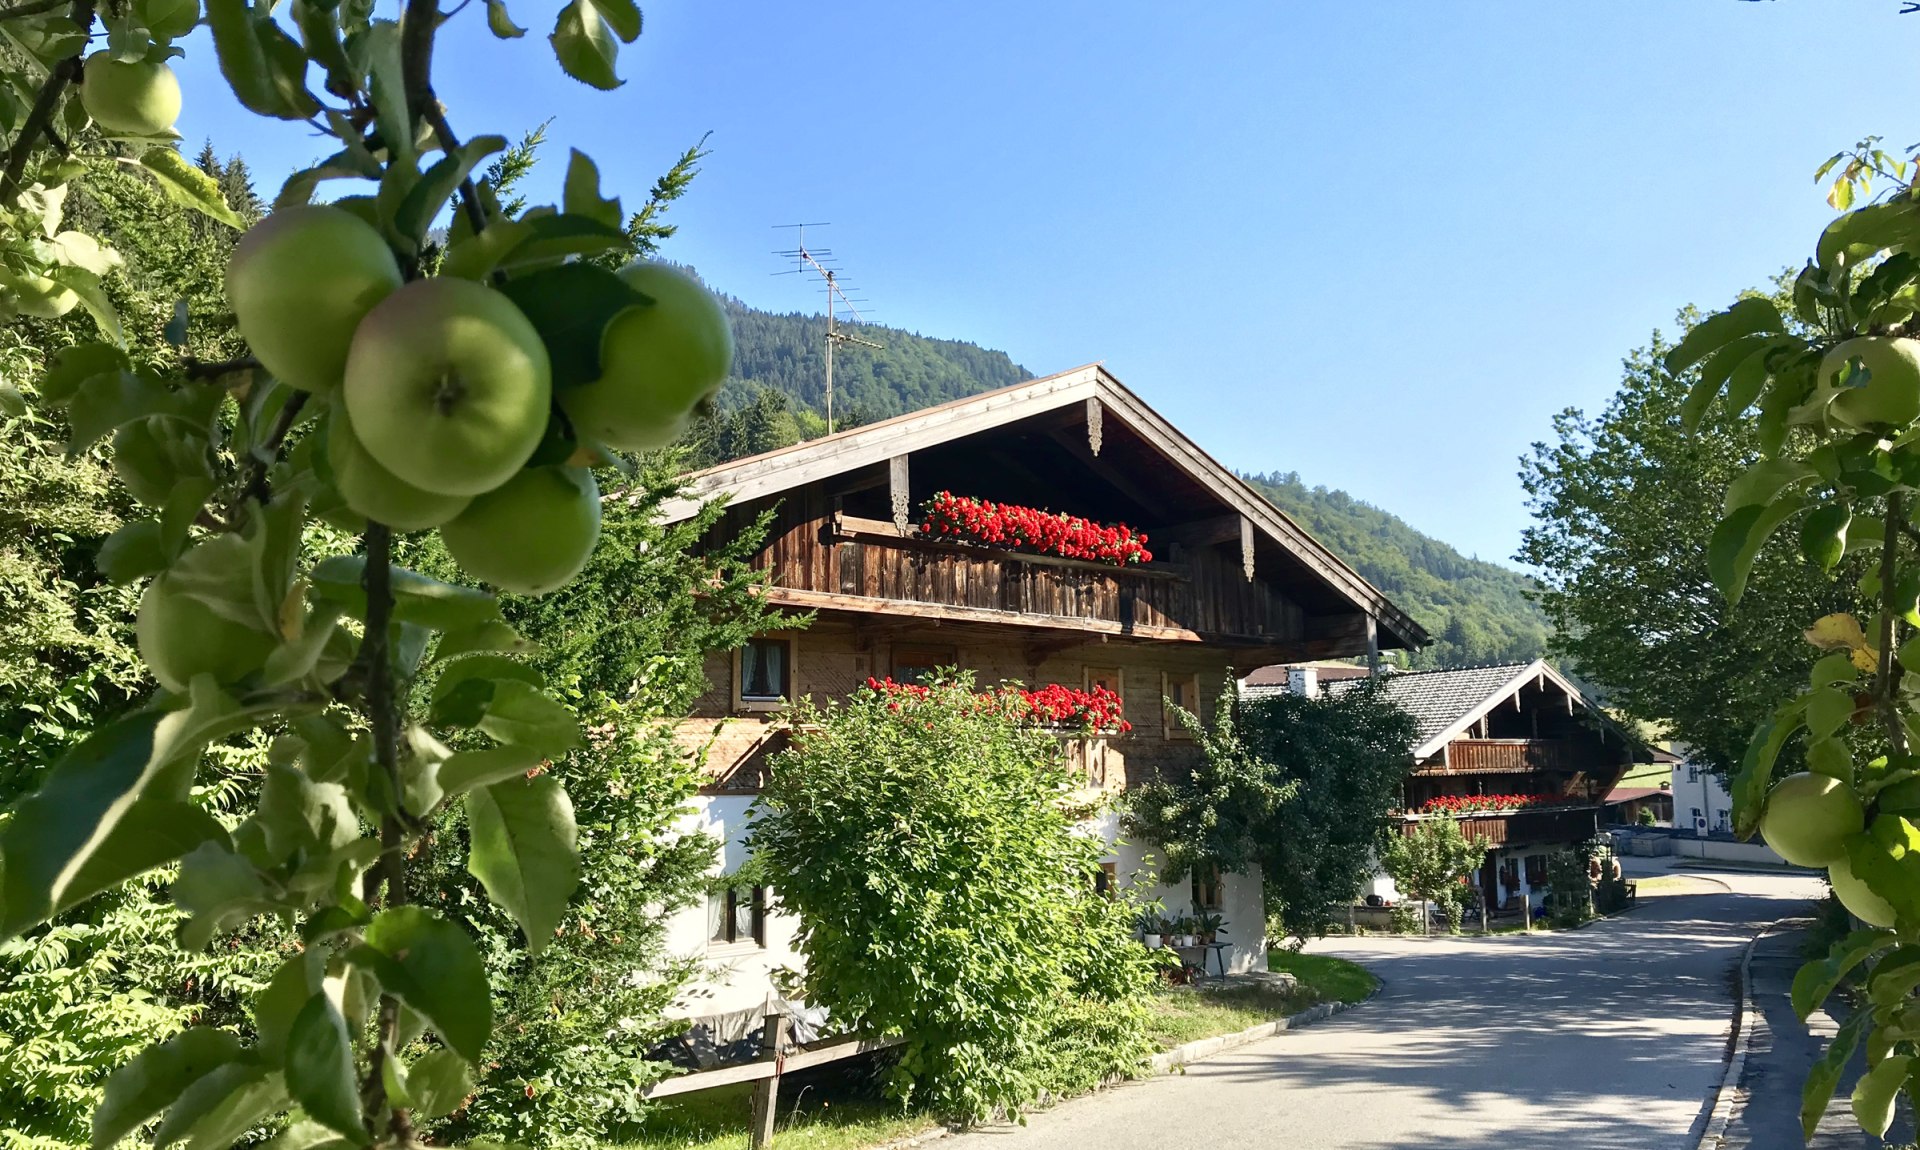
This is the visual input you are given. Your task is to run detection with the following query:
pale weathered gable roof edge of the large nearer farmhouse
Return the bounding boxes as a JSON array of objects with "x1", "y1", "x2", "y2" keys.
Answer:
[{"x1": 660, "y1": 365, "x2": 1428, "y2": 647}]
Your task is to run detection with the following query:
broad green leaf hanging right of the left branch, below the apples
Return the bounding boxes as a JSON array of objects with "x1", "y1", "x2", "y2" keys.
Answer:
[{"x1": 467, "y1": 776, "x2": 580, "y2": 954}]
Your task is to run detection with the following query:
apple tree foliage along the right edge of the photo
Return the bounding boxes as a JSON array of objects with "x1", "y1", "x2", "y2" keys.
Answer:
[{"x1": 1697, "y1": 142, "x2": 1920, "y2": 1137}]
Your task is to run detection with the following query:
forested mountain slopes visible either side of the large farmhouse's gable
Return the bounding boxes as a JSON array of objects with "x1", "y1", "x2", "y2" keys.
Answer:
[{"x1": 691, "y1": 298, "x2": 1548, "y2": 666}]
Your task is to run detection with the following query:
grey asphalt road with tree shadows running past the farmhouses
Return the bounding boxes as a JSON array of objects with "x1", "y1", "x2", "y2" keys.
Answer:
[{"x1": 950, "y1": 874, "x2": 1818, "y2": 1150}]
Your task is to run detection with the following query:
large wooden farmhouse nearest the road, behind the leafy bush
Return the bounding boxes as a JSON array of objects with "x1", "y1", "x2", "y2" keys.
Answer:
[{"x1": 664, "y1": 367, "x2": 1427, "y2": 1036}]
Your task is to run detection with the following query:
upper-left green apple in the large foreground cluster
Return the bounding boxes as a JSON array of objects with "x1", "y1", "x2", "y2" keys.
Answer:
[{"x1": 227, "y1": 204, "x2": 401, "y2": 392}]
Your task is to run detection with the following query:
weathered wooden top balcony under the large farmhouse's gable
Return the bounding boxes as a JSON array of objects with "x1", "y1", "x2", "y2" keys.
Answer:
[{"x1": 768, "y1": 515, "x2": 1308, "y2": 645}]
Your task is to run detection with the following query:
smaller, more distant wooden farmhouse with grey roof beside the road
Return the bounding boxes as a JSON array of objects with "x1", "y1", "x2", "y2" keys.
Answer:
[{"x1": 1327, "y1": 660, "x2": 1653, "y2": 908}]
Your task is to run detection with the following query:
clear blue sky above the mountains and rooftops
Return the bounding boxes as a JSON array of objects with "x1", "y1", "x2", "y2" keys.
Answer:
[{"x1": 179, "y1": 0, "x2": 1920, "y2": 572}]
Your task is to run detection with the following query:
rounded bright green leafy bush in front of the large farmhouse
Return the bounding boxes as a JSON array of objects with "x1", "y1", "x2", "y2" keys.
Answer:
[{"x1": 749, "y1": 678, "x2": 1152, "y2": 1121}]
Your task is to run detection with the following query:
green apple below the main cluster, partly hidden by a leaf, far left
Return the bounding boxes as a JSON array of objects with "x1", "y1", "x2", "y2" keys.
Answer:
[{"x1": 134, "y1": 536, "x2": 278, "y2": 691}]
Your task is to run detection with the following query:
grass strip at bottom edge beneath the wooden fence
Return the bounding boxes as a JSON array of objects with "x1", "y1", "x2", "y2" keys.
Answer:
[{"x1": 607, "y1": 1083, "x2": 935, "y2": 1150}]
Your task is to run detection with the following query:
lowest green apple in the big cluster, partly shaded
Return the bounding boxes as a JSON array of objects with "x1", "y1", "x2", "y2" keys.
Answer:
[{"x1": 440, "y1": 467, "x2": 599, "y2": 595}]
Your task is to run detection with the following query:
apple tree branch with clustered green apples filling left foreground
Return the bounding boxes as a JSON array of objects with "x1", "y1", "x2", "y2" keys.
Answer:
[{"x1": 0, "y1": 0, "x2": 732, "y2": 1150}]
